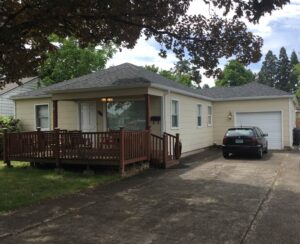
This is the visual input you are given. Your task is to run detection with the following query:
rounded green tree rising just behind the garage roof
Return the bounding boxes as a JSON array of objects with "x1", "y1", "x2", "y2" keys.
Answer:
[{"x1": 216, "y1": 60, "x2": 255, "y2": 87}]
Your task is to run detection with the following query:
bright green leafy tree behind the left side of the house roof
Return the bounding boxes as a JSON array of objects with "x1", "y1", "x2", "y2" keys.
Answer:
[{"x1": 38, "y1": 36, "x2": 115, "y2": 85}]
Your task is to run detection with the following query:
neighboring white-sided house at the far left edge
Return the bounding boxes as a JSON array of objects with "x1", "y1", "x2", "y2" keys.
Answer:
[{"x1": 0, "y1": 77, "x2": 39, "y2": 116}]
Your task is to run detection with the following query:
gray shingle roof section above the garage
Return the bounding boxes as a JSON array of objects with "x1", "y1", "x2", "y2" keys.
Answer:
[{"x1": 198, "y1": 82, "x2": 292, "y2": 100}]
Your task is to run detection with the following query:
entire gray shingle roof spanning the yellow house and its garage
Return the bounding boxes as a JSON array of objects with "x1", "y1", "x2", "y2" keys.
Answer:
[{"x1": 13, "y1": 63, "x2": 292, "y2": 100}]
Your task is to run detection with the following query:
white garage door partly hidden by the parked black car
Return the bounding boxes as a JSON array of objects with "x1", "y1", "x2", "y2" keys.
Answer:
[{"x1": 235, "y1": 112, "x2": 282, "y2": 149}]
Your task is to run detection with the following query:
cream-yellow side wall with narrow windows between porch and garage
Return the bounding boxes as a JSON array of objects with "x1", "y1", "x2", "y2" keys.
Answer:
[{"x1": 164, "y1": 93, "x2": 214, "y2": 153}]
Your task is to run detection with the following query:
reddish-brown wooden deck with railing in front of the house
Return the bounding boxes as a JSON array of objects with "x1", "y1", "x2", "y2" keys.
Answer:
[{"x1": 3, "y1": 128, "x2": 180, "y2": 173}]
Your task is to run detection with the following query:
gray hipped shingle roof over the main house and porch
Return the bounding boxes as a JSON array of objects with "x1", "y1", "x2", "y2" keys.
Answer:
[{"x1": 13, "y1": 63, "x2": 208, "y2": 99}]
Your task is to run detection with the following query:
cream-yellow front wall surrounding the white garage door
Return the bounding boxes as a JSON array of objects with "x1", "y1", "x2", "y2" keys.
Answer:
[{"x1": 213, "y1": 98, "x2": 294, "y2": 147}]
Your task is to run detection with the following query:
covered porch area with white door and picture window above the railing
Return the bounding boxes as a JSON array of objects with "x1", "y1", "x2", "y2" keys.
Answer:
[{"x1": 50, "y1": 90, "x2": 164, "y2": 136}]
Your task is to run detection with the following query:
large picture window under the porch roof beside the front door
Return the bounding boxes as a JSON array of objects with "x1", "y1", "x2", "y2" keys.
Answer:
[{"x1": 107, "y1": 101, "x2": 146, "y2": 130}]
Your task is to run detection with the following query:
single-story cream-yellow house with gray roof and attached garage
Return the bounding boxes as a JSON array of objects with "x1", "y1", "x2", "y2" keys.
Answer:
[{"x1": 14, "y1": 63, "x2": 297, "y2": 153}]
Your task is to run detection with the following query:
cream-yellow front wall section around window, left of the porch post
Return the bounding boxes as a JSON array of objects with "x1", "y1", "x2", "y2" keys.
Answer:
[{"x1": 16, "y1": 98, "x2": 53, "y2": 131}]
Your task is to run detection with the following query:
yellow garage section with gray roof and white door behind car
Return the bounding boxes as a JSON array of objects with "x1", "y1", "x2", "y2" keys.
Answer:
[{"x1": 201, "y1": 82, "x2": 298, "y2": 149}]
